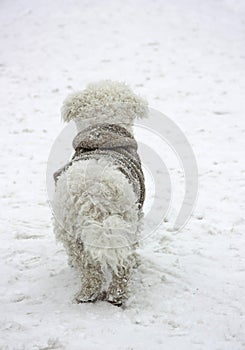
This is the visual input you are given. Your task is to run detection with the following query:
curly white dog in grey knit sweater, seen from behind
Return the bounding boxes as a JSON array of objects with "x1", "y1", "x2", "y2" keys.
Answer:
[{"x1": 53, "y1": 80, "x2": 148, "y2": 306}]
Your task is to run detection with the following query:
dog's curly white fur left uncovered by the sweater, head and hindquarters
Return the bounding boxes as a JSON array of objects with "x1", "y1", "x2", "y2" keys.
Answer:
[{"x1": 54, "y1": 80, "x2": 148, "y2": 305}]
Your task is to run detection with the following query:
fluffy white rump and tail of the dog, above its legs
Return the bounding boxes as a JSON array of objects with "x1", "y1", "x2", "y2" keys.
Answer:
[{"x1": 54, "y1": 159, "x2": 142, "y2": 269}]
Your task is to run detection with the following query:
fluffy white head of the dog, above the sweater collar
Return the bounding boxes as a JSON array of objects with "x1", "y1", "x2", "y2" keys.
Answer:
[{"x1": 61, "y1": 80, "x2": 148, "y2": 132}]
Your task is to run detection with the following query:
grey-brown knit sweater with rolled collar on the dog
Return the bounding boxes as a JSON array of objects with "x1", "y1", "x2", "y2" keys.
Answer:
[{"x1": 54, "y1": 123, "x2": 145, "y2": 208}]
